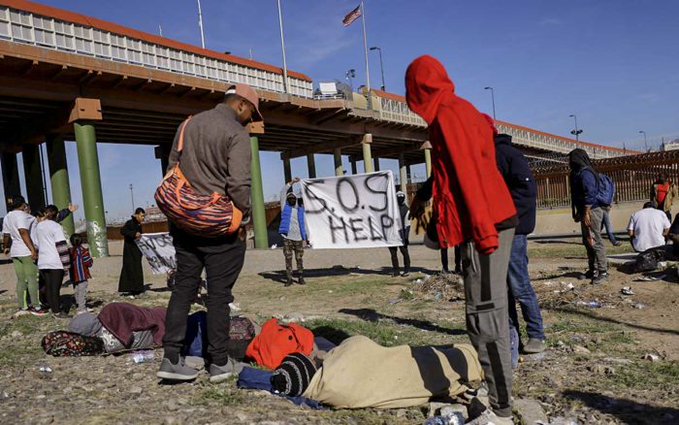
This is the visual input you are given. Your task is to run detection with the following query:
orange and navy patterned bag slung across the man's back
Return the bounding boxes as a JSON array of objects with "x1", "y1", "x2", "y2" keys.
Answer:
[{"x1": 155, "y1": 117, "x2": 243, "y2": 238}]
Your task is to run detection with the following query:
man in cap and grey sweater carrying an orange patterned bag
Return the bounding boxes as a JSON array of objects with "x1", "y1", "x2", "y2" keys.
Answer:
[{"x1": 156, "y1": 84, "x2": 262, "y2": 383}]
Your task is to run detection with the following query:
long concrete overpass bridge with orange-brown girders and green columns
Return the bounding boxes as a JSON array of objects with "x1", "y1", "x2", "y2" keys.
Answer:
[{"x1": 0, "y1": 0, "x2": 624, "y2": 256}]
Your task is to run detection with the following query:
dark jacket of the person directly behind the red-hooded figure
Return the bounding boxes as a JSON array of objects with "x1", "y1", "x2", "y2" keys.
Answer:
[{"x1": 495, "y1": 134, "x2": 537, "y2": 235}]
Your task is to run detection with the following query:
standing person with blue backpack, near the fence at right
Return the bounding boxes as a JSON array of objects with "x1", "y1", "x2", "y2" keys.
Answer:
[{"x1": 568, "y1": 149, "x2": 612, "y2": 284}]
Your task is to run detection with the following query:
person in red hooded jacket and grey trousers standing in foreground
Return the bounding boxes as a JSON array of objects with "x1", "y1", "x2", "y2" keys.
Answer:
[{"x1": 406, "y1": 56, "x2": 518, "y2": 424}]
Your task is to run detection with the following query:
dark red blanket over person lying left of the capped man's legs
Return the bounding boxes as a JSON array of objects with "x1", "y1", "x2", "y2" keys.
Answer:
[{"x1": 98, "y1": 303, "x2": 167, "y2": 348}]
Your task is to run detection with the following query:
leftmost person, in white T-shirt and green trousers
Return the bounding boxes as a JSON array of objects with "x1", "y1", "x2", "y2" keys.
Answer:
[{"x1": 2, "y1": 196, "x2": 44, "y2": 315}]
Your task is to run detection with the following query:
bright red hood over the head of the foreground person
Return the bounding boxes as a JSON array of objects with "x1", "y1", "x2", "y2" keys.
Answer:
[{"x1": 406, "y1": 55, "x2": 455, "y2": 125}]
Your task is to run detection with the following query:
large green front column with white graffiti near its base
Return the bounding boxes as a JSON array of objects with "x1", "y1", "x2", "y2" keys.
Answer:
[{"x1": 73, "y1": 123, "x2": 108, "y2": 257}]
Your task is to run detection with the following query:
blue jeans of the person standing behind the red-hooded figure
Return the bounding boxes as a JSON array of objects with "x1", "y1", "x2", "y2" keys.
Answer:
[{"x1": 507, "y1": 235, "x2": 545, "y2": 348}]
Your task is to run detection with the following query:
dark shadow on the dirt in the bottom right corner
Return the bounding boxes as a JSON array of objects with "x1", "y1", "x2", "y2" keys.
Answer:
[{"x1": 563, "y1": 390, "x2": 679, "y2": 425}]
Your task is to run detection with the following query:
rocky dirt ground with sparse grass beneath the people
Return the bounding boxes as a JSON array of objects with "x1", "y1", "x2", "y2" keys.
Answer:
[{"x1": 0, "y1": 241, "x2": 679, "y2": 425}]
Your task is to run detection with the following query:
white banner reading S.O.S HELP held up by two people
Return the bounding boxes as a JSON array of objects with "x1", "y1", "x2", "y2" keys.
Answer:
[{"x1": 302, "y1": 171, "x2": 403, "y2": 248}]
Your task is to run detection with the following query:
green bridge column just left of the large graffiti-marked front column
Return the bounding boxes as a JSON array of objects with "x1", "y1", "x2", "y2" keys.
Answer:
[{"x1": 47, "y1": 137, "x2": 75, "y2": 236}]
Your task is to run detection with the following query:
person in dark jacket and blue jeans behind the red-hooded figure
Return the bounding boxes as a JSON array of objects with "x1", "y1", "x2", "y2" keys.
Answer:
[{"x1": 495, "y1": 134, "x2": 545, "y2": 358}]
